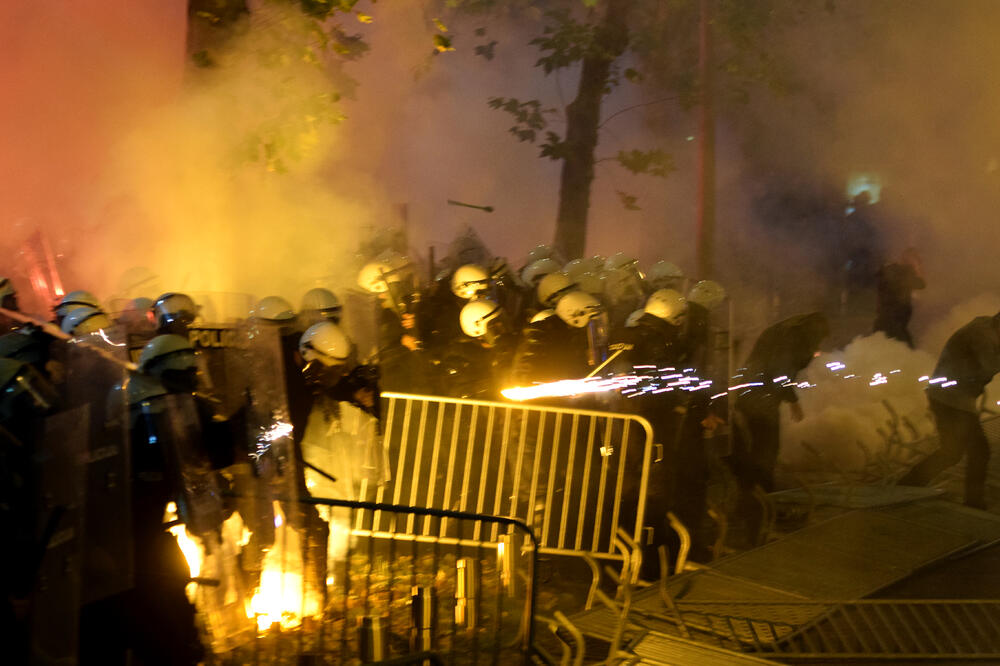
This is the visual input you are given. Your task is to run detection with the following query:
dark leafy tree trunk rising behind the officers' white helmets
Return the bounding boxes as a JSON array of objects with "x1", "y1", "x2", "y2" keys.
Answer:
[{"x1": 553, "y1": 0, "x2": 632, "y2": 259}]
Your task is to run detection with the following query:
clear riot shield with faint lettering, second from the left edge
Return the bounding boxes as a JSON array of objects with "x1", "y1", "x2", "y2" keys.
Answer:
[{"x1": 64, "y1": 337, "x2": 134, "y2": 604}]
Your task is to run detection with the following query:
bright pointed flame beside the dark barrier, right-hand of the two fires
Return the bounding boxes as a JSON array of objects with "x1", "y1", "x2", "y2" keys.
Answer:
[{"x1": 247, "y1": 502, "x2": 320, "y2": 632}]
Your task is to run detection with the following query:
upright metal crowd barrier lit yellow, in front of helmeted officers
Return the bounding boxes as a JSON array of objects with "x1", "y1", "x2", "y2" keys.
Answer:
[{"x1": 376, "y1": 392, "x2": 654, "y2": 560}]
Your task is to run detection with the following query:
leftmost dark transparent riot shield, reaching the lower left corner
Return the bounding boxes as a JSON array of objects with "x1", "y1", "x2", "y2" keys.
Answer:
[{"x1": 29, "y1": 406, "x2": 92, "y2": 664}]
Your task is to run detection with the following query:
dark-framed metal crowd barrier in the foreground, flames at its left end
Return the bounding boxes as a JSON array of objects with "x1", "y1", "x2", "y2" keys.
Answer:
[{"x1": 204, "y1": 498, "x2": 537, "y2": 664}]
